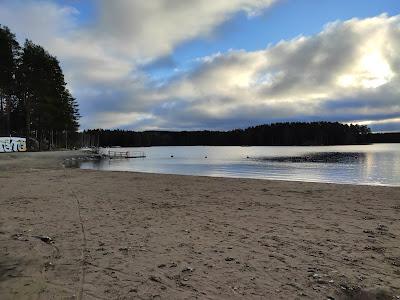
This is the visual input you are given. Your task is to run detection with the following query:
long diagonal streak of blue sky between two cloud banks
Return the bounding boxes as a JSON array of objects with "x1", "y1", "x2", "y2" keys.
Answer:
[{"x1": 168, "y1": 0, "x2": 400, "y2": 73}]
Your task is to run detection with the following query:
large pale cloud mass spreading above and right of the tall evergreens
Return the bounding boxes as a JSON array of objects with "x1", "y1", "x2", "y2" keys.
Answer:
[{"x1": 0, "y1": 0, "x2": 275, "y2": 127}]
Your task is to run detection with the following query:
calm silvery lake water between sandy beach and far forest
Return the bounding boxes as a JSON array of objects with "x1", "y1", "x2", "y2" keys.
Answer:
[{"x1": 80, "y1": 144, "x2": 400, "y2": 186}]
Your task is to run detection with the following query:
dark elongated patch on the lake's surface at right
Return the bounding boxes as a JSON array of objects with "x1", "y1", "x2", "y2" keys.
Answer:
[{"x1": 257, "y1": 152, "x2": 366, "y2": 163}]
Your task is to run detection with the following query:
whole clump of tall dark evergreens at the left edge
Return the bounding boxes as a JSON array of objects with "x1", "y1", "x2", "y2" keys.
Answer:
[{"x1": 0, "y1": 25, "x2": 80, "y2": 146}]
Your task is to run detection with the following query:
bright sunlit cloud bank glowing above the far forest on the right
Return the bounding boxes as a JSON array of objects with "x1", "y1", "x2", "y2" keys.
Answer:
[{"x1": 140, "y1": 15, "x2": 400, "y2": 129}]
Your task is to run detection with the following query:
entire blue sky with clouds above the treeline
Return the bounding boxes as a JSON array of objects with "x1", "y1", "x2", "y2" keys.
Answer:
[{"x1": 0, "y1": 0, "x2": 400, "y2": 131}]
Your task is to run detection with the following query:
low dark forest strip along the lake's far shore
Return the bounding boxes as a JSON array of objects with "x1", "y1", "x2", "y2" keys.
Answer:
[{"x1": 77, "y1": 122, "x2": 390, "y2": 147}]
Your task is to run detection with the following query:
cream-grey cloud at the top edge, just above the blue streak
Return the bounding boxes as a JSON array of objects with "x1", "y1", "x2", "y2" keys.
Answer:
[{"x1": 95, "y1": 0, "x2": 275, "y2": 59}]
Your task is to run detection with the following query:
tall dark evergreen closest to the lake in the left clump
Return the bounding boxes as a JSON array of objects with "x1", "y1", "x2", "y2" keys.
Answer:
[{"x1": 17, "y1": 40, "x2": 79, "y2": 148}]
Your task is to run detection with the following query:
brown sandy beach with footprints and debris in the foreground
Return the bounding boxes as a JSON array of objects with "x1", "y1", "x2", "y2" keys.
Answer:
[{"x1": 0, "y1": 151, "x2": 400, "y2": 299}]
